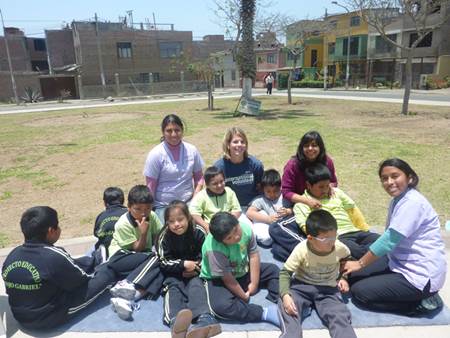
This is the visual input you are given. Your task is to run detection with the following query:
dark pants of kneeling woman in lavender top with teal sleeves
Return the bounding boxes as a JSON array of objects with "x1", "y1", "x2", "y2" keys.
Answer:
[{"x1": 349, "y1": 257, "x2": 435, "y2": 315}]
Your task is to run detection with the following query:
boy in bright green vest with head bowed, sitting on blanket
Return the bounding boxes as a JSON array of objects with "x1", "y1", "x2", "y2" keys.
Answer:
[{"x1": 200, "y1": 212, "x2": 279, "y2": 326}]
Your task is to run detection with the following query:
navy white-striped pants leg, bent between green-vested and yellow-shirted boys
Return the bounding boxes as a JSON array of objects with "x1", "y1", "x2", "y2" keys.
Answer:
[{"x1": 269, "y1": 216, "x2": 306, "y2": 262}]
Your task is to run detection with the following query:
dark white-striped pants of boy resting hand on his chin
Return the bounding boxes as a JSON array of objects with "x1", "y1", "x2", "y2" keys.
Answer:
[{"x1": 108, "y1": 250, "x2": 164, "y2": 299}]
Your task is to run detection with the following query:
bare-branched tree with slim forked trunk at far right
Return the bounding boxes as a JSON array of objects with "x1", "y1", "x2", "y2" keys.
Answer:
[{"x1": 347, "y1": 0, "x2": 450, "y2": 115}]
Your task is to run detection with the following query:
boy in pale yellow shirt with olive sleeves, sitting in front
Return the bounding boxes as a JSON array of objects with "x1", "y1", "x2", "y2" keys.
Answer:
[{"x1": 279, "y1": 210, "x2": 356, "y2": 338}]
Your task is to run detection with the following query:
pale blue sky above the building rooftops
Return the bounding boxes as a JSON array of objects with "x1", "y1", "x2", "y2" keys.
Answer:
[{"x1": 0, "y1": 0, "x2": 339, "y2": 39}]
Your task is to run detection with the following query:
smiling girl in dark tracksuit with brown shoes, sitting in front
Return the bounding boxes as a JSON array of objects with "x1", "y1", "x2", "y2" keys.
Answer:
[{"x1": 157, "y1": 201, "x2": 221, "y2": 338}]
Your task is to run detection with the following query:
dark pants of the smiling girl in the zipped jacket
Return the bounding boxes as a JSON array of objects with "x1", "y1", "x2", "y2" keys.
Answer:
[{"x1": 164, "y1": 277, "x2": 210, "y2": 325}]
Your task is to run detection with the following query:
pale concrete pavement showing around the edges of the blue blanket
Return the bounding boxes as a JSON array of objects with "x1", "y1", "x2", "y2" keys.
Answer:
[{"x1": 0, "y1": 232, "x2": 450, "y2": 338}]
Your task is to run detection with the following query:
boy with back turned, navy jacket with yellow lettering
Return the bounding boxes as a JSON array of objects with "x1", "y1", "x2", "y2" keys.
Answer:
[{"x1": 2, "y1": 206, "x2": 117, "y2": 329}]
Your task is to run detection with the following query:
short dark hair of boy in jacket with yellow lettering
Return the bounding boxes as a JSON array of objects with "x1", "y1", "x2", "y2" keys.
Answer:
[{"x1": 20, "y1": 206, "x2": 58, "y2": 242}]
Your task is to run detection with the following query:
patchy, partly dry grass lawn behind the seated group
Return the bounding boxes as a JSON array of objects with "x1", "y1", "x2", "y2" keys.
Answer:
[{"x1": 0, "y1": 97, "x2": 450, "y2": 247}]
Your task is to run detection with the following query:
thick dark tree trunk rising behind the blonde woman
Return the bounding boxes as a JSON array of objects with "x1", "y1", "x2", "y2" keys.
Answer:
[{"x1": 237, "y1": 0, "x2": 256, "y2": 99}]
